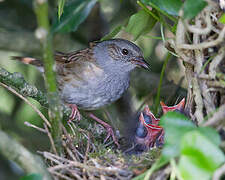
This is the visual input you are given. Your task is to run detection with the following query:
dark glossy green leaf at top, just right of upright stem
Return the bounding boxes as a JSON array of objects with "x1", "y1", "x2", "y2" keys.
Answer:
[{"x1": 52, "y1": 0, "x2": 97, "y2": 33}]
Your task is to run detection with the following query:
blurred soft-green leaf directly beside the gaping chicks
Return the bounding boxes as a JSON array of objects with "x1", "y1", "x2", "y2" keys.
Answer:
[{"x1": 160, "y1": 112, "x2": 196, "y2": 158}]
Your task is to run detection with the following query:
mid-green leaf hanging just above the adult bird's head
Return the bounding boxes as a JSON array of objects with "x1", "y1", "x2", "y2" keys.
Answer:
[{"x1": 126, "y1": 10, "x2": 156, "y2": 40}]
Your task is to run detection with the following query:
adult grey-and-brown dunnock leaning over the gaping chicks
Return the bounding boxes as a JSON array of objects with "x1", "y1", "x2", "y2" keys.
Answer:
[{"x1": 14, "y1": 39, "x2": 149, "y2": 145}]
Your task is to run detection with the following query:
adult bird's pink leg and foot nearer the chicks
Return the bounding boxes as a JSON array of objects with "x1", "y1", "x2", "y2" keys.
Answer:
[{"x1": 89, "y1": 113, "x2": 120, "y2": 147}]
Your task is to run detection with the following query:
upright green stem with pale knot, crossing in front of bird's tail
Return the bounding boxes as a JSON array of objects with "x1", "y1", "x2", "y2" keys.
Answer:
[{"x1": 34, "y1": 0, "x2": 62, "y2": 151}]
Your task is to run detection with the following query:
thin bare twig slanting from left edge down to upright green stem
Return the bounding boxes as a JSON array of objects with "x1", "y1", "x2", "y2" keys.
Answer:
[{"x1": 0, "y1": 82, "x2": 51, "y2": 127}]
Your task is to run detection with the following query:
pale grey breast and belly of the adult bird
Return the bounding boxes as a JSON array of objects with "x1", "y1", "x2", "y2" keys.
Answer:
[{"x1": 59, "y1": 63, "x2": 129, "y2": 110}]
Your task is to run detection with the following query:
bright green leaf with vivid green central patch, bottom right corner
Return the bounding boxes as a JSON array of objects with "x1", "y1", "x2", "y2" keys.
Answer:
[{"x1": 179, "y1": 130, "x2": 225, "y2": 180}]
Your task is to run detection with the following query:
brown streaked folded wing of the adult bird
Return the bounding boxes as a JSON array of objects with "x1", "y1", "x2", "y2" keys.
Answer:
[{"x1": 55, "y1": 45, "x2": 104, "y2": 90}]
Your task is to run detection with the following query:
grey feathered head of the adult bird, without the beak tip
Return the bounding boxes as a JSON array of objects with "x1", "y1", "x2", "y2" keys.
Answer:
[{"x1": 93, "y1": 39, "x2": 143, "y2": 74}]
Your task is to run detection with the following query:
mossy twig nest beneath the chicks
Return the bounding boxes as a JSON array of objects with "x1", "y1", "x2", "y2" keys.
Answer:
[{"x1": 39, "y1": 123, "x2": 160, "y2": 180}]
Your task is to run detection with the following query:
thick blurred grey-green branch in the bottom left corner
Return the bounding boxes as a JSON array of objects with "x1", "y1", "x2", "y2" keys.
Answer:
[{"x1": 0, "y1": 130, "x2": 51, "y2": 180}]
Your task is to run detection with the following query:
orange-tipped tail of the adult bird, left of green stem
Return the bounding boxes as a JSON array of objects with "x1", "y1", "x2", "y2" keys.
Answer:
[{"x1": 11, "y1": 56, "x2": 44, "y2": 72}]
